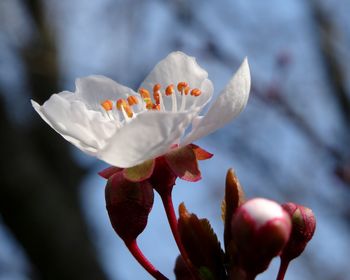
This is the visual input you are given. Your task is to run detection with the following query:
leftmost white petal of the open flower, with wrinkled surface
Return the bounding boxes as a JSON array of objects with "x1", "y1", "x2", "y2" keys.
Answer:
[{"x1": 32, "y1": 92, "x2": 116, "y2": 154}]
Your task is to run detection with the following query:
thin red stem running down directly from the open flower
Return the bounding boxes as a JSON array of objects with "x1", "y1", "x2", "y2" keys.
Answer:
[{"x1": 159, "y1": 191, "x2": 199, "y2": 279}]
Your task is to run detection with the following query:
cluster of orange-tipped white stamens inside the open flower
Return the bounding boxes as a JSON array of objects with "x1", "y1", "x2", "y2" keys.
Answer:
[{"x1": 101, "y1": 82, "x2": 202, "y2": 121}]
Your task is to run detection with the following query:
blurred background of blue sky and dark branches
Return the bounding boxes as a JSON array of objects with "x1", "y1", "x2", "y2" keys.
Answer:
[{"x1": 0, "y1": 0, "x2": 350, "y2": 280}]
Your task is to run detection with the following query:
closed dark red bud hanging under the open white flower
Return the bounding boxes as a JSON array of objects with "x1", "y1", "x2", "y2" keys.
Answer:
[{"x1": 105, "y1": 171, "x2": 154, "y2": 243}]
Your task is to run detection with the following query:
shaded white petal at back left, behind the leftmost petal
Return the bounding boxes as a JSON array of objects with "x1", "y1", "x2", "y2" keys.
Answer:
[{"x1": 75, "y1": 75, "x2": 136, "y2": 110}]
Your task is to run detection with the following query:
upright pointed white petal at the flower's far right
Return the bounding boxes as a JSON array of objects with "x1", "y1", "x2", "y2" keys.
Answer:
[{"x1": 182, "y1": 58, "x2": 250, "y2": 145}]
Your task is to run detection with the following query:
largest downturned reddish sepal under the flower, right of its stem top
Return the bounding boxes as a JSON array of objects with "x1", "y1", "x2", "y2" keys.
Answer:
[{"x1": 164, "y1": 145, "x2": 201, "y2": 182}]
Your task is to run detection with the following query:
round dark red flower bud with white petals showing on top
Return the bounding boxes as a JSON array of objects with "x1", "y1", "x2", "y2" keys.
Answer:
[{"x1": 231, "y1": 198, "x2": 291, "y2": 277}]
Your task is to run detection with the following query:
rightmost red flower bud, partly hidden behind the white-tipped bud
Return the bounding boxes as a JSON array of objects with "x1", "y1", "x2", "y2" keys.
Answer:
[{"x1": 281, "y1": 202, "x2": 316, "y2": 261}]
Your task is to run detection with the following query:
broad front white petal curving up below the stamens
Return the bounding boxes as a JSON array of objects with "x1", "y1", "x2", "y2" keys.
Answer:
[{"x1": 97, "y1": 111, "x2": 196, "y2": 168}]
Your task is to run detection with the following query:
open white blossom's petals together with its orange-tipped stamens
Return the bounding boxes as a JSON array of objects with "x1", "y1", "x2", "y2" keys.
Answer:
[{"x1": 32, "y1": 52, "x2": 250, "y2": 168}]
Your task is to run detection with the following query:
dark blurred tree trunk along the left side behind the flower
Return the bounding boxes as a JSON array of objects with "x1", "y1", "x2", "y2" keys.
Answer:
[{"x1": 0, "y1": 0, "x2": 106, "y2": 280}]
